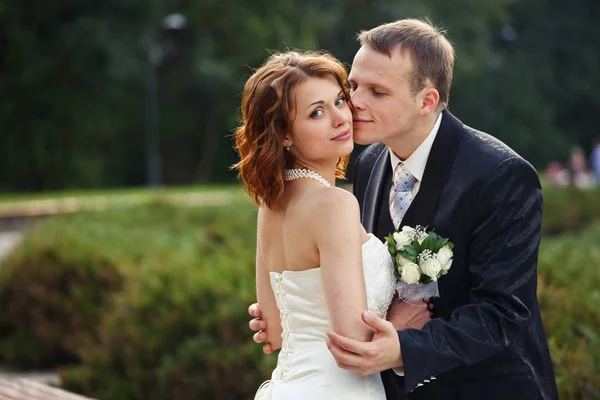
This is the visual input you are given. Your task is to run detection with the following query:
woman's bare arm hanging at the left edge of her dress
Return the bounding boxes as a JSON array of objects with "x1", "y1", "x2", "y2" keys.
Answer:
[{"x1": 256, "y1": 223, "x2": 281, "y2": 350}]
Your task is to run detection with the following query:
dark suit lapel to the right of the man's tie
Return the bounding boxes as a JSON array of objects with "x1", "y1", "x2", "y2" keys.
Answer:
[{"x1": 401, "y1": 110, "x2": 464, "y2": 229}]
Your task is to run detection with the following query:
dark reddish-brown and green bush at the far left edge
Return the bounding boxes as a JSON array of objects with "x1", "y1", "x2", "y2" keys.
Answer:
[{"x1": 0, "y1": 217, "x2": 126, "y2": 368}]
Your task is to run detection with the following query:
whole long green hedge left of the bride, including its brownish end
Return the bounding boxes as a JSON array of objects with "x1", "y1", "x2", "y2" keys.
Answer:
[{"x1": 0, "y1": 203, "x2": 275, "y2": 400}]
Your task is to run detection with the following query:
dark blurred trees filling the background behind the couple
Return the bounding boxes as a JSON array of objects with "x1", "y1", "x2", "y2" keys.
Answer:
[{"x1": 0, "y1": 0, "x2": 600, "y2": 191}]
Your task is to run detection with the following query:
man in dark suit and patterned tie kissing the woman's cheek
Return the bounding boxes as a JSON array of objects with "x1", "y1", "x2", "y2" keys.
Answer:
[{"x1": 251, "y1": 19, "x2": 558, "y2": 400}]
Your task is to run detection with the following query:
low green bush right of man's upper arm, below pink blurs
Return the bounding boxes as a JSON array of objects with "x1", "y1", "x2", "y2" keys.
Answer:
[{"x1": 542, "y1": 186, "x2": 600, "y2": 235}]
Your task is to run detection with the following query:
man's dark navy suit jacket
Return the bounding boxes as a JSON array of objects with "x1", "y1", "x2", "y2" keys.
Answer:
[{"x1": 354, "y1": 111, "x2": 558, "y2": 400}]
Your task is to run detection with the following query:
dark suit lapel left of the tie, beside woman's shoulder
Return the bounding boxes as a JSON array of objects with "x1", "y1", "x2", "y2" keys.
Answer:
[{"x1": 362, "y1": 146, "x2": 392, "y2": 233}]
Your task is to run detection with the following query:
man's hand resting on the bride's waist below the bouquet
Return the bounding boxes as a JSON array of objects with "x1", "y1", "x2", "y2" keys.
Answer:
[{"x1": 327, "y1": 312, "x2": 403, "y2": 376}]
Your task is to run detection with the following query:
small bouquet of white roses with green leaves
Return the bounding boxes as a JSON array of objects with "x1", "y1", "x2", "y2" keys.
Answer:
[{"x1": 385, "y1": 225, "x2": 454, "y2": 301}]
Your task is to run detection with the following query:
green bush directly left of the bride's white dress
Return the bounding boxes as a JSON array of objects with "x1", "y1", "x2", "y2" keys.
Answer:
[{"x1": 56, "y1": 202, "x2": 275, "y2": 400}]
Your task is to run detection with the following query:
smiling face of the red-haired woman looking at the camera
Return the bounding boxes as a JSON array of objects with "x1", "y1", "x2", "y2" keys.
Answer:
[{"x1": 284, "y1": 77, "x2": 354, "y2": 166}]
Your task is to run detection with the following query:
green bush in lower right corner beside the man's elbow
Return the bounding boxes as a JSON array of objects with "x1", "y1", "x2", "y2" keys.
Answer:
[{"x1": 538, "y1": 222, "x2": 600, "y2": 400}]
